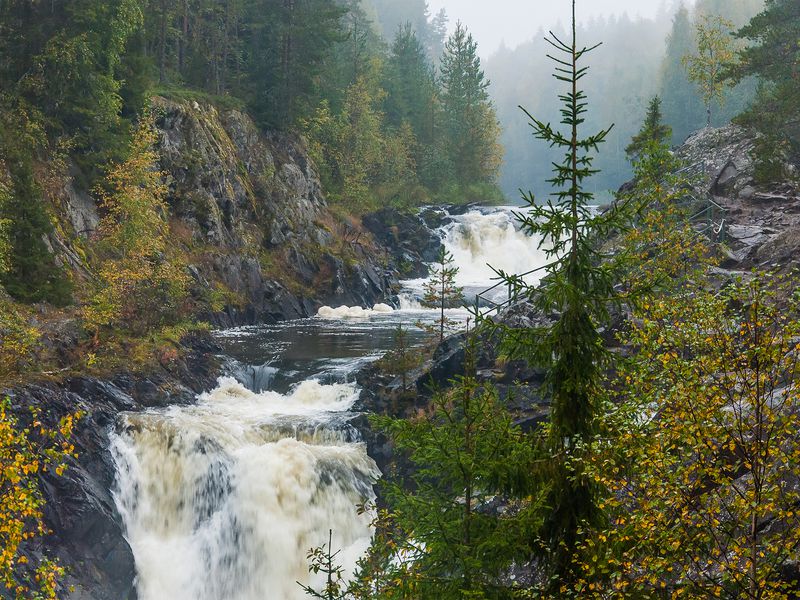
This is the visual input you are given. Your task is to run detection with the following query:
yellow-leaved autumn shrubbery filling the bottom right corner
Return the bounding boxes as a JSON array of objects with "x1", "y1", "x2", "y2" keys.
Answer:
[{"x1": 564, "y1": 276, "x2": 800, "y2": 600}]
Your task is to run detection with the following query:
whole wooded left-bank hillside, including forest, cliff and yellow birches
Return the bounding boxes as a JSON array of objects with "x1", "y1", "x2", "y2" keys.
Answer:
[{"x1": 0, "y1": 0, "x2": 502, "y2": 380}]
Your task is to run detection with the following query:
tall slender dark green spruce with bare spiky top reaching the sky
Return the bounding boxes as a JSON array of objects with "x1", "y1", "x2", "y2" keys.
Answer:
[{"x1": 494, "y1": 1, "x2": 627, "y2": 590}]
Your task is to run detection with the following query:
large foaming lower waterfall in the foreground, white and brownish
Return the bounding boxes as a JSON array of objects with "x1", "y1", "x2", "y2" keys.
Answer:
[{"x1": 112, "y1": 378, "x2": 379, "y2": 600}]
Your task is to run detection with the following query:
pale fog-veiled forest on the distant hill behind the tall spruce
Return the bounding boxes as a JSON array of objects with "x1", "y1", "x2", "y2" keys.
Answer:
[{"x1": 486, "y1": 0, "x2": 764, "y2": 200}]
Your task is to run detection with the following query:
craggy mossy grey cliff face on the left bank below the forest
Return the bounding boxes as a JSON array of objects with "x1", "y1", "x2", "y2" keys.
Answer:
[{"x1": 148, "y1": 98, "x2": 396, "y2": 326}]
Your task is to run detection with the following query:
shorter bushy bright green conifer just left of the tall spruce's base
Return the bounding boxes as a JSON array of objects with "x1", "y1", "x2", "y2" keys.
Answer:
[{"x1": 367, "y1": 336, "x2": 539, "y2": 600}]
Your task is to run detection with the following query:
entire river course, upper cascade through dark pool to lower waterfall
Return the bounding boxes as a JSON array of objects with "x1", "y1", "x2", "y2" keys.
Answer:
[{"x1": 112, "y1": 204, "x2": 542, "y2": 600}]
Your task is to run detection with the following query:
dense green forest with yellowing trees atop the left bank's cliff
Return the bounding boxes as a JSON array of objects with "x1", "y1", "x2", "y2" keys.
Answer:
[{"x1": 0, "y1": 0, "x2": 500, "y2": 212}]
